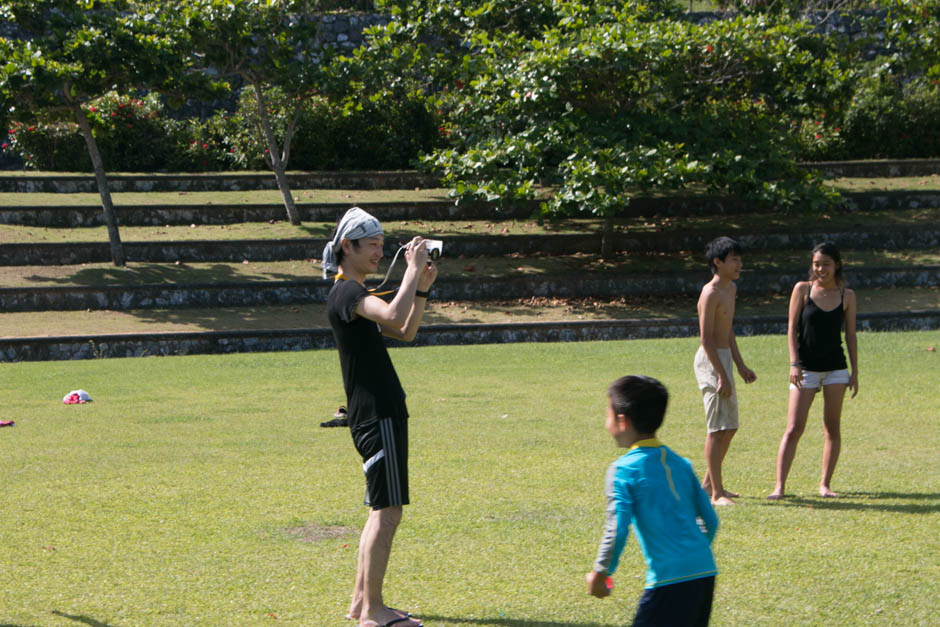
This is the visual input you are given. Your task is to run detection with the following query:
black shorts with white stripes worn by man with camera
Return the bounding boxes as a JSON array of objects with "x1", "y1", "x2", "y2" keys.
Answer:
[{"x1": 353, "y1": 418, "x2": 409, "y2": 509}]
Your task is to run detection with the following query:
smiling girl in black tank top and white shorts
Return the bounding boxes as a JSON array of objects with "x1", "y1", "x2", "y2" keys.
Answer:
[{"x1": 767, "y1": 242, "x2": 858, "y2": 500}]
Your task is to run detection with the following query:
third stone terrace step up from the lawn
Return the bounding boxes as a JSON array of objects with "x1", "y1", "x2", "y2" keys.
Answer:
[{"x1": 0, "y1": 225, "x2": 940, "y2": 266}]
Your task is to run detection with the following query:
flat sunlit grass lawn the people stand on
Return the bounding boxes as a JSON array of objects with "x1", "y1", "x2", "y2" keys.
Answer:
[{"x1": 0, "y1": 332, "x2": 940, "y2": 627}]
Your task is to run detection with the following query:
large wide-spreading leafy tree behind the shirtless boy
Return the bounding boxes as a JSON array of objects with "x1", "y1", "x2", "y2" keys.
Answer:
[{"x1": 361, "y1": 0, "x2": 847, "y2": 254}]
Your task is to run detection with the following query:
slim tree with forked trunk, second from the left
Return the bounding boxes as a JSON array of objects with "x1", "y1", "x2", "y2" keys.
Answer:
[{"x1": 174, "y1": 0, "x2": 332, "y2": 224}]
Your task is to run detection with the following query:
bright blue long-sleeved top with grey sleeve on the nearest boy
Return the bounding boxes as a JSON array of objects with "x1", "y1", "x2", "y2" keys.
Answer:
[{"x1": 594, "y1": 439, "x2": 718, "y2": 588}]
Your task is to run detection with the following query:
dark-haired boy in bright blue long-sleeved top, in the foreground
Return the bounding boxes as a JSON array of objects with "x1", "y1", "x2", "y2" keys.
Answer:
[{"x1": 586, "y1": 376, "x2": 718, "y2": 626}]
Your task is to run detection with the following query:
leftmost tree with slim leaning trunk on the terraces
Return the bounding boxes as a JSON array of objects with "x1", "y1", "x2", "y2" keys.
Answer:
[{"x1": 0, "y1": 0, "x2": 191, "y2": 266}]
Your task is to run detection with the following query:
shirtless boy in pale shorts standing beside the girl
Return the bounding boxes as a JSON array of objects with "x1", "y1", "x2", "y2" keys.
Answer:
[{"x1": 693, "y1": 237, "x2": 757, "y2": 505}]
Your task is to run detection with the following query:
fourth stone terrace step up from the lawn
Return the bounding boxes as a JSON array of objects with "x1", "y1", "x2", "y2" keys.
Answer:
[{"x1": 0, "y1": 190, "x2": 940, "y2": 227}]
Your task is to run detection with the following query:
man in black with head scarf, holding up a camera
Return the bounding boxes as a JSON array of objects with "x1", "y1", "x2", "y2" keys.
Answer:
[{"x1": 323, "y1": 207, "x2": 437, "y2": 627}]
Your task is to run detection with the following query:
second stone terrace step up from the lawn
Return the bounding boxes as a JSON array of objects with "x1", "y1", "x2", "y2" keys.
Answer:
[{"x1": 0, "y1": 266, "x2": 940, "y2": 312}]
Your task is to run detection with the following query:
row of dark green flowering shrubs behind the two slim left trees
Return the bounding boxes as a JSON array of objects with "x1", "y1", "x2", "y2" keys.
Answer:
[{"x1": 0, "y1": 89, "x2": 440, "y2": 172}]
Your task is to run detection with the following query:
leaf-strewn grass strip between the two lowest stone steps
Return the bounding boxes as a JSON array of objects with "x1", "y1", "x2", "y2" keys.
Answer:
[{"x1": 0, "y1": 287, "x2": 940, "y2": 337}]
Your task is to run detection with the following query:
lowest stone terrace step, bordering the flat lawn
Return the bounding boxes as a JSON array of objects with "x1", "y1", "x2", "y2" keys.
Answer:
[{"x1": 0, "y1": 309, "x2": 940, "y2": 362}]
